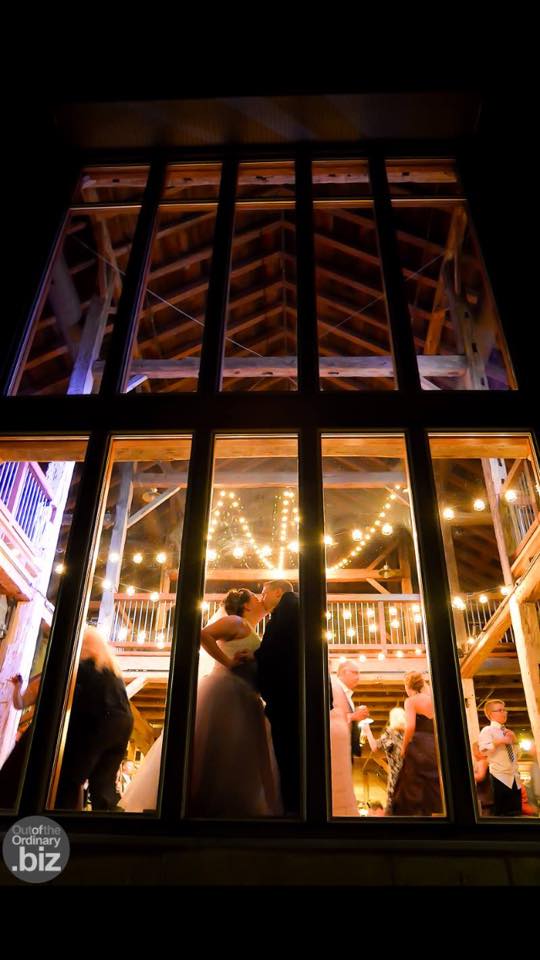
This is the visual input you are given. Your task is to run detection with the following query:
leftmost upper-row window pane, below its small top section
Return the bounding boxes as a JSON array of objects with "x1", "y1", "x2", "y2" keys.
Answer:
[{"x1": 16, "y1": 210, "x2": 137, "y2": 395}]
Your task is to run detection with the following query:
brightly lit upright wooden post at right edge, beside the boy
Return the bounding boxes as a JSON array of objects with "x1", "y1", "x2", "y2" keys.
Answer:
[{"x1": 510, "y1": 597, "x2": 540, "y2": 749}]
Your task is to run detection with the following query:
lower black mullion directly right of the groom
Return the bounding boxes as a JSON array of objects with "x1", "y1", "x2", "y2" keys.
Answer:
[{"x1": 298, "y1": 426, "x2": 329, "y2": 825}]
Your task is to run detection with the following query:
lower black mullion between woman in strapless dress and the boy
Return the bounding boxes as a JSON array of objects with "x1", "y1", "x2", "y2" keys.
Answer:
[{"x1": 407, "y1": 428, "x2": 475, "y2": 827}]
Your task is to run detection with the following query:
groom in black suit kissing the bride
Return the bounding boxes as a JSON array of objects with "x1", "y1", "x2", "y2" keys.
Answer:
[{"x1": 255, "y1": 580, "x2": 300, "y2": 816}]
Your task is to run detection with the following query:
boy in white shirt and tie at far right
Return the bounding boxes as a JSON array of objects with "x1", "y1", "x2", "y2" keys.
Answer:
[{"x1": 478, "y1": 700, "x2": 521, "y2": 817}]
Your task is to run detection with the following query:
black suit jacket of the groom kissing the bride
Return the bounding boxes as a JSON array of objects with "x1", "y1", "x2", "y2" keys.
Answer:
[{"x1": 255, "y1": 593, "x2": 300, "y2": 723}]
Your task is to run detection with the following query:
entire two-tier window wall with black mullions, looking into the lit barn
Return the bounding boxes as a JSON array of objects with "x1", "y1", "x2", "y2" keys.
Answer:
[{"x1": 0, "y1": 150, "x2": 540, "y2": 835}]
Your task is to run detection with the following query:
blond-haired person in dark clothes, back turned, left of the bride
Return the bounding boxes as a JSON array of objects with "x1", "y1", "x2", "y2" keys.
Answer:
[{"x1": 55, "y1": 626, "x2": 133, "y2": 810}]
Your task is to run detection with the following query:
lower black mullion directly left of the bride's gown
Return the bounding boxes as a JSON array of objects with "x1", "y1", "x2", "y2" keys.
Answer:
[{"x1": 161, "y1": 430, "x2": 214, "y2": 825}]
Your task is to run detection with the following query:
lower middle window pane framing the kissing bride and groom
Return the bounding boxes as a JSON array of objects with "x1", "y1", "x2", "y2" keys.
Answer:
[{"x1": 189, "y1": 437, "x2": 299, "y2": 819}]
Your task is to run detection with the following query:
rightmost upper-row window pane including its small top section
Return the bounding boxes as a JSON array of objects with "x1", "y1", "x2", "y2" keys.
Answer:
[{"x1": 388, "y1": 161, "x2": 515, "y2": 390}]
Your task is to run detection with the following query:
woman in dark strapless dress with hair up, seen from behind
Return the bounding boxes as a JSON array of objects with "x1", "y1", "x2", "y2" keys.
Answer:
[{"x1": 392, "y1": 672, "x2": 442, "y2": 817}]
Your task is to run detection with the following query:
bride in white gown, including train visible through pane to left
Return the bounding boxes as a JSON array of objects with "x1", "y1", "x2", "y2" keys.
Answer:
[{"x1": 119, "y1": 589, "x2": 282, "y2": 818}]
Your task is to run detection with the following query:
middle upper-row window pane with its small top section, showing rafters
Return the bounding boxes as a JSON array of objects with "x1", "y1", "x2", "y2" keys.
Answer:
[{"x1": 223, "y1": 163, "x2": 296, "y2": 391}]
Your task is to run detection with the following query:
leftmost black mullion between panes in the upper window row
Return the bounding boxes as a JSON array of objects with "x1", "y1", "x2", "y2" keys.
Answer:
[{"x1": 100, "y1": 156, "x2": 166, "y2": 397}]
